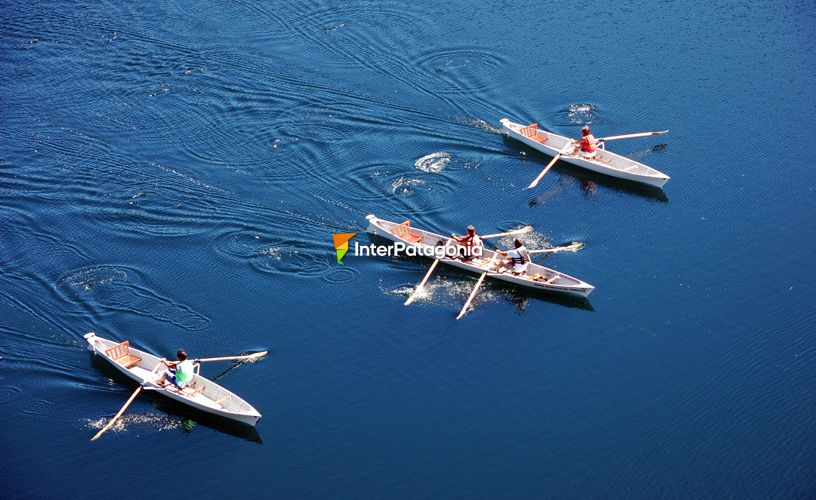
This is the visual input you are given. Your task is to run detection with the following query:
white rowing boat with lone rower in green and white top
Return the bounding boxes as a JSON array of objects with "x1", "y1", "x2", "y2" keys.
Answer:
[{"x1": 85, "y1": 332, "x2": 261, "y2": 426}]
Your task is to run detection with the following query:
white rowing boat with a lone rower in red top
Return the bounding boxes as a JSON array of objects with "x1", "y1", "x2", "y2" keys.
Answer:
[{"x1": 501, "y1": 118, "x2": 670, "y2": 188}]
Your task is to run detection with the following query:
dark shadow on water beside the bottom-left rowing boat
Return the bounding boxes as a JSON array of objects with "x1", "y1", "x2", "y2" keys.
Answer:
[{"x1": 88, "y1": 352, "x2": 263, "y2": 444}]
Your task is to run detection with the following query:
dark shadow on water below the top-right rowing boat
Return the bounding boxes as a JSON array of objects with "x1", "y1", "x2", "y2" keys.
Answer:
[{"x1": 502, "y1": 136, "x2": 669, "y2": 202}]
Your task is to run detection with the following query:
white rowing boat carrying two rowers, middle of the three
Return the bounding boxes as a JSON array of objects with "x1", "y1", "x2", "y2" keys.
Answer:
[{"x1": 366, "y1": 215, "x2": 595, "y2": 297}]
